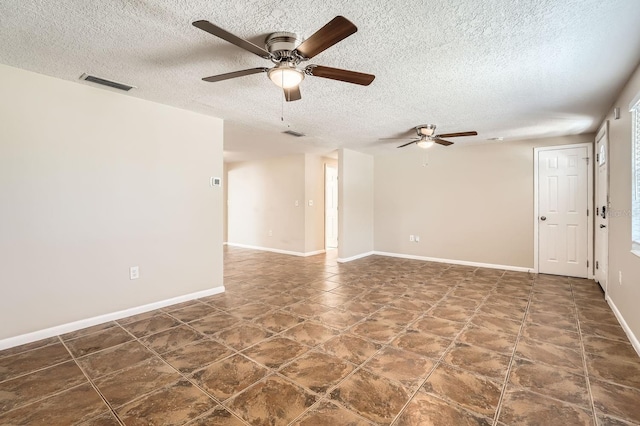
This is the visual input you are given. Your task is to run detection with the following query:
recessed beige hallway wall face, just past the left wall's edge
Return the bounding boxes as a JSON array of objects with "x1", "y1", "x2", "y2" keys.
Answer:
[{"x1": 227, "y1": 154, "x2": 305, "y2": 253}]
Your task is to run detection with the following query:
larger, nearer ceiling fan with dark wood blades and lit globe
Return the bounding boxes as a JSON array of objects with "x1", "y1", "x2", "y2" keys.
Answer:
[{"x1": 193, "y1": 16, "x2": 375, "y2": 102}]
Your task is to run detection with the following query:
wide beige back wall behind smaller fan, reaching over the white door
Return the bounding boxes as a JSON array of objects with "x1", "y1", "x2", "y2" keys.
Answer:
[{"x1": 374, "y1": 134, "x2": 594, "y2": 268}]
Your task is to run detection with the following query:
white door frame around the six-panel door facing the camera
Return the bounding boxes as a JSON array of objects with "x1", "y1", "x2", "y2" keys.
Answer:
[{"x1": 533, "y1": 142, "x2": 594, "y2": 279}]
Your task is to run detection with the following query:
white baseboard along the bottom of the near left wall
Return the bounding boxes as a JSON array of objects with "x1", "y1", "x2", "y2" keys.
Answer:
[{"x1": 0, "y1": 286, "x2": 224, "y2": 350}]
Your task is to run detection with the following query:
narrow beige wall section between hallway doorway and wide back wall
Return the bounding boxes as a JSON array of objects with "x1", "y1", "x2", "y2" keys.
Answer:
[{"x1": 338, "y1": 149, "x2": 374, "y2": 260}]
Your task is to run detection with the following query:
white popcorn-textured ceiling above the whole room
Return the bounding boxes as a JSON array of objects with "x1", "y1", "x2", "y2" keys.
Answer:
[{"x1": 0, "y1": 0, "x2": 640, "y2": 161}]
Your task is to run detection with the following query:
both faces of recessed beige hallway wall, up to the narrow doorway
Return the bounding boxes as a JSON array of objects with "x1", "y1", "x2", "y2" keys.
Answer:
[{"x1": 225, "y1": 154, "x2": 335, "y2": 255}]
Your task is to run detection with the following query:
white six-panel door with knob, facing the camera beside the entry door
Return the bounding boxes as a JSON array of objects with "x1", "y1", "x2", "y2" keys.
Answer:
[{"x1": 537, "y1": 147, "x2": 589, "y2": 278}]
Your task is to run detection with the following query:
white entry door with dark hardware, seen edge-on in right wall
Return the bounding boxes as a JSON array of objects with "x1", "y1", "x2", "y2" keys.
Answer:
[{"x1": 594, "y1": 121, "x2": 609, "y2": 292}]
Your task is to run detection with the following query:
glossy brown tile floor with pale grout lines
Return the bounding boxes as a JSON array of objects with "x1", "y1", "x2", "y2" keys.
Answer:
[{"x1": 0, "y1": 249, "x2": 640, "y2": 426}]
